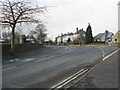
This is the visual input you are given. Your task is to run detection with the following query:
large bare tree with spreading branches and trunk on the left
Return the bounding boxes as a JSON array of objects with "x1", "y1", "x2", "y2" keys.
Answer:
[{"x1": 0, "y1": 0, "x2": 46, "y2": 54}]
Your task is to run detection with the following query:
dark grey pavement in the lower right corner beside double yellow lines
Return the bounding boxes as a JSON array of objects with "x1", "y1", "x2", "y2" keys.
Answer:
[{"x1": 71, "y1": 47, "x2": 120, "y2": 90}]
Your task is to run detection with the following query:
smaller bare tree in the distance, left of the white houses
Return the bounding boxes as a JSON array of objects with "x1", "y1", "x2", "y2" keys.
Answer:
[{"x1": 35, "y1": 24, "x2": 47, "y2": 44}]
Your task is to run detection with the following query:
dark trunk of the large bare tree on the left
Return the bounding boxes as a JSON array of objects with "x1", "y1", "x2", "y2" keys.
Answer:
[{"x1": 11, "y1": 25, "x2": 15, "y2": 55}]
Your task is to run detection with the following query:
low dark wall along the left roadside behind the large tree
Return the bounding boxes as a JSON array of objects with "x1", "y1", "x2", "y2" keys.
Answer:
[{"x1": 2, "y1": 43, "x2": 43, "y2": 56}]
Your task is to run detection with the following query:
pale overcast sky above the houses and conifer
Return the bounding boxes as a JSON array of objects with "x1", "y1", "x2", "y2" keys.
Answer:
[{"x1": 37, "y1": 0, "x2": 119, "y2": 39}]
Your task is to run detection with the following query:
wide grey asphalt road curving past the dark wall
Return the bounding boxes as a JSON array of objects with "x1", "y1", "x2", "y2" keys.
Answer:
[{"x1": 2, "y1": 46, "x2": 117, "y2": 88}]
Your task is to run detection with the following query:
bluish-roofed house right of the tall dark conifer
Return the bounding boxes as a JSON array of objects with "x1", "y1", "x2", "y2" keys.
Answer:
[{"x1": 94, "y1": 30, "x2": 114, "y2": 43}]
